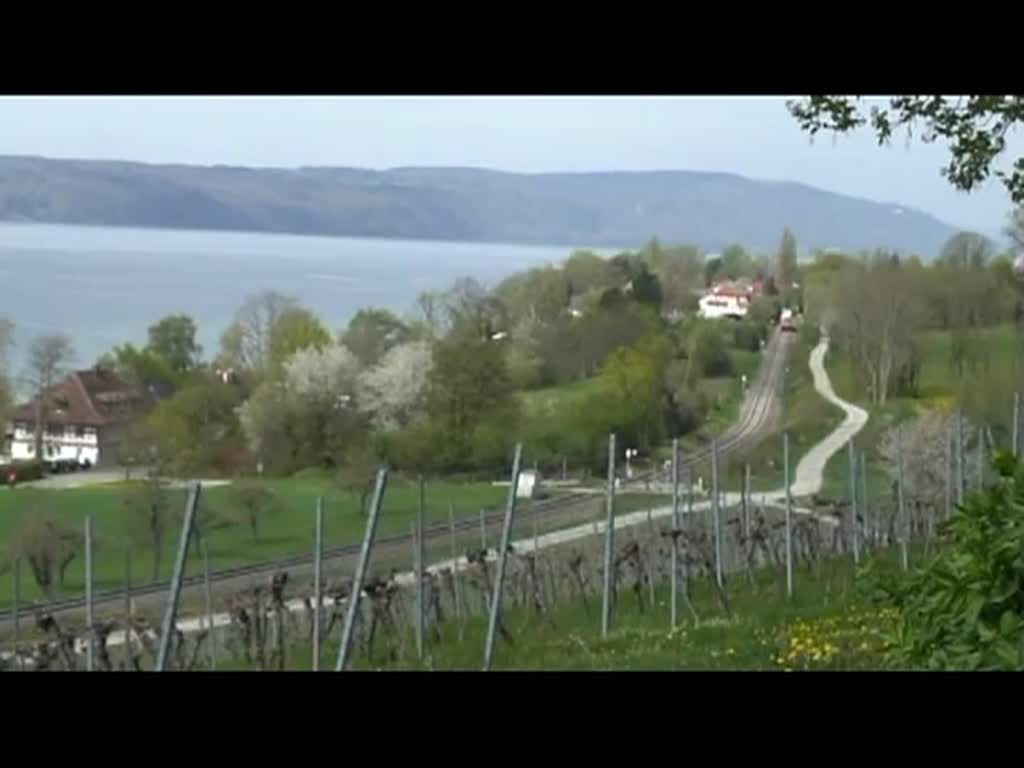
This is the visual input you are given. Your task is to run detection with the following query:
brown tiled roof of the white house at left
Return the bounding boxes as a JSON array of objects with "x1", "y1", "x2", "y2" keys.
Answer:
[{"x1": 13, "y1": 368, "x2": 153, "y2": 427}]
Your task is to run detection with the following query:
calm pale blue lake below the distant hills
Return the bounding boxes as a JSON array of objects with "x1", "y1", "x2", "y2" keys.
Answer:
[{"x1": 0, "y1": 224, "x2": 593, "y2": 370}]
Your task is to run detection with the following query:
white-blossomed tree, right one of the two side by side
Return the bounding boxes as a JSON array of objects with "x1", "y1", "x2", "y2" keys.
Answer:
[{"x1": 356, "y1": 341, "x2": 433, "y2": 430}]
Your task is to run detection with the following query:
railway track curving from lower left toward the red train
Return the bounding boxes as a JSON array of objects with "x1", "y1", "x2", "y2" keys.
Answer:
[{"x1": 0, "y1": 331, "x2": 788, "y2": 628}]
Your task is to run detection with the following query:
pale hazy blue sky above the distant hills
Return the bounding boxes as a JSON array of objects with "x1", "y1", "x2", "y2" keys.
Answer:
[{"x1": 0, "y1": 96, "x2": 1024, "y2": 234}]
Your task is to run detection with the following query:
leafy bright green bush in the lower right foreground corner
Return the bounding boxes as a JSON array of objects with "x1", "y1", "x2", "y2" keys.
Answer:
[{"x1": 872, "y1": 454, "x2": 1024, "y2": 670}]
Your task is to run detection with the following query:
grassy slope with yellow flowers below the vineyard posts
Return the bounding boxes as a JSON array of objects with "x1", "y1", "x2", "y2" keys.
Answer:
[{"x1": 220, "y1": 555, "x2": 894, "y2": 670}]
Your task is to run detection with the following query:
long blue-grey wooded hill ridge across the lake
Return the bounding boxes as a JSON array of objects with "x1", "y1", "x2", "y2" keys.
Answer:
[{"x1": 0, "y1": 157, "x2": 954, "y2": 258}]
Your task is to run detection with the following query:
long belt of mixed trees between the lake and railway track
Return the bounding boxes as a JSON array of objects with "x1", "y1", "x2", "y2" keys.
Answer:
[{"x1": 0, "y1": 233, "x2": 796, "y2": 486}]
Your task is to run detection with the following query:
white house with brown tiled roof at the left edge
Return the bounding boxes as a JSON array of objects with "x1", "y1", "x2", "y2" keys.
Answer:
[{"x1": 9, "y1": 367, "x2": 155, "y2": 467}]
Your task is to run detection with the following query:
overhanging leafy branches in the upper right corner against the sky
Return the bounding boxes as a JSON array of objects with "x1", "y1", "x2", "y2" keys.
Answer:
[{"x1": 787, "y1": 95, "x2": 1024, "y2": 205}]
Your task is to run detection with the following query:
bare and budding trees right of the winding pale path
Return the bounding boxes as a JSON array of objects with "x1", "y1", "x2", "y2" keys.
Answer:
[{"x1": 806, "y1": 225, "x2": 1024, "y2": 421}]
